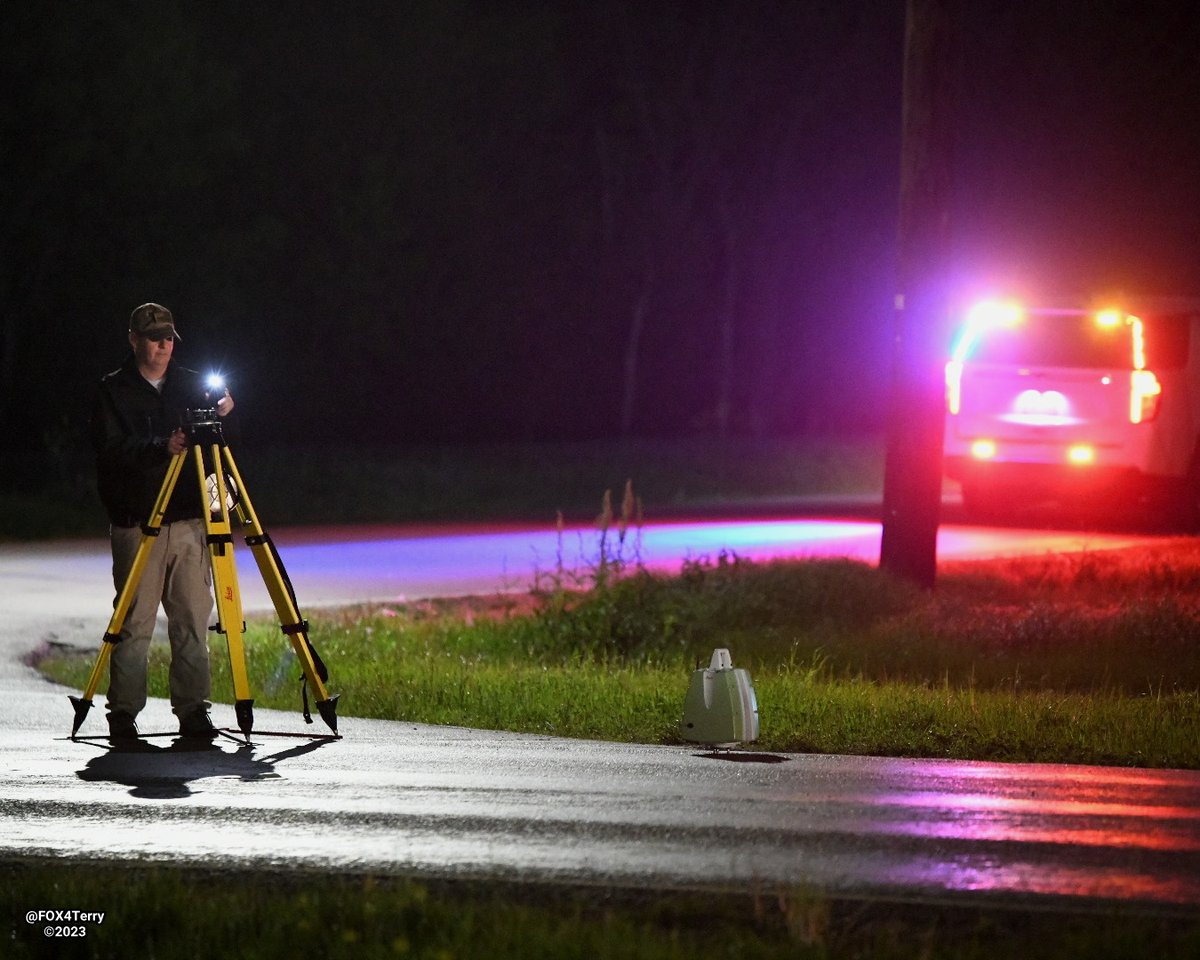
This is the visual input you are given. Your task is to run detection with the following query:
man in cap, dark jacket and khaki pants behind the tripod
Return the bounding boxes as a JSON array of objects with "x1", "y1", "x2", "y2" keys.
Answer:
[{"x1": 91, "y1": 304, "x2": 233, "y2": 740}]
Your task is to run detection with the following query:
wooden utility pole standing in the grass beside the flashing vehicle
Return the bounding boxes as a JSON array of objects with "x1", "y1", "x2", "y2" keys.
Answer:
[{"x1": 880, "y1": 0, "x2": 958, "y2": 589}]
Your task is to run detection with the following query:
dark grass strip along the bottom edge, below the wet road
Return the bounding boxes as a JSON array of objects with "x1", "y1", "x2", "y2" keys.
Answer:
[{"x1": 7, "y1": 862, "x2": 1200, "y2": 960}]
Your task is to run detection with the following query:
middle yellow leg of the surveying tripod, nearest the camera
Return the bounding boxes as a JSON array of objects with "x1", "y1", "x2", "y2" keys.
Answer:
[{"x1": 193, "y1": 444, "x2": 254, "y2": 737}]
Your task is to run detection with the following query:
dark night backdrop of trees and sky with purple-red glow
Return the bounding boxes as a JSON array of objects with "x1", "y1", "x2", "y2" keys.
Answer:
[{"x1": 0, "y1": 0, "x2": 1200, "y2": 456}]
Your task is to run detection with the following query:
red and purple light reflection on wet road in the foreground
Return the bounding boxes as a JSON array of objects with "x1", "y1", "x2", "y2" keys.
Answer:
[{"x1": 866, "y1": 761, "x2": 1200, "y2": 904}]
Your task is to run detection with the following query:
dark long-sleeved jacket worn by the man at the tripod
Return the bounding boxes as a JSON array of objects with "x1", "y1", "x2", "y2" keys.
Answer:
[{"x1": 91, "y1": 354, "x2": 211, "y2": 527}]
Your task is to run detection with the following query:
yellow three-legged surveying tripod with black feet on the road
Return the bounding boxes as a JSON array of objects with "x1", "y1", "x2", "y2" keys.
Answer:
[{"x1": 68, "y1": 393, "x2": 341, "y2": 742}]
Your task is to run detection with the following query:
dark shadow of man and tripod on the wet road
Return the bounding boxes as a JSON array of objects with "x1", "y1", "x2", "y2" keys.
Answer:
[{"x1": 77, "y1": 738, "x2": 331, "y2": 800}]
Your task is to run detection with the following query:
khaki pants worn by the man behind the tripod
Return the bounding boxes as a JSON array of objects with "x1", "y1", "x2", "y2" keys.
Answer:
[{"x1": 108, "y1": 520, "x2": 212, "y2": 716}]
